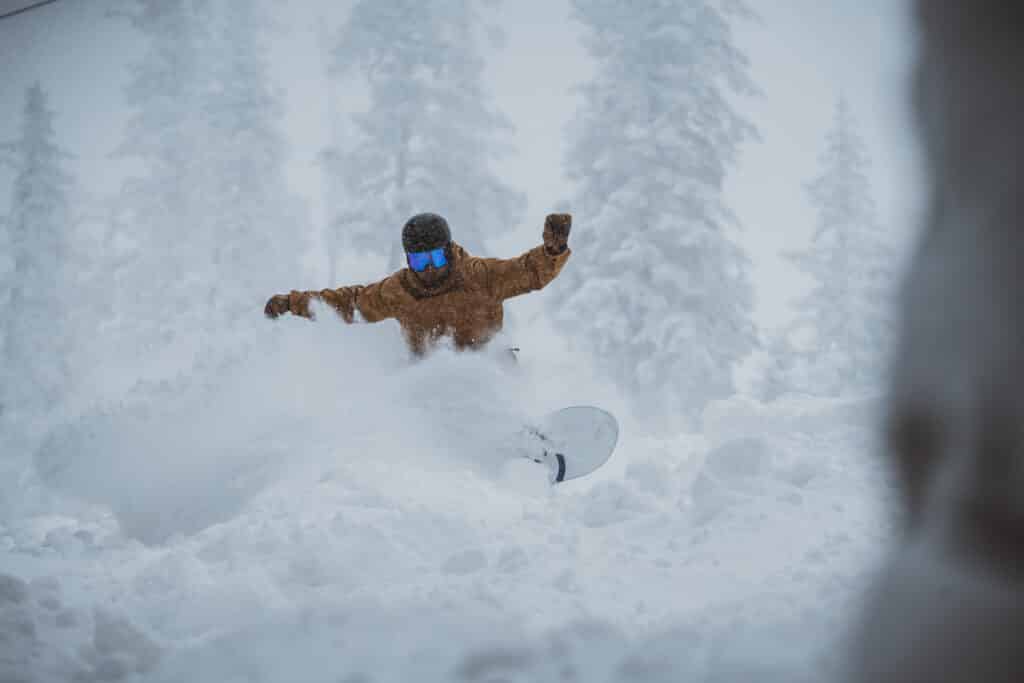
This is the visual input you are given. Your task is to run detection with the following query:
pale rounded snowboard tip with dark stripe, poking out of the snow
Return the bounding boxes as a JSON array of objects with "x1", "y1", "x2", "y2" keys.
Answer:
[{"x1": 518, "y1": 405, "x2": 618, "y2": 484}]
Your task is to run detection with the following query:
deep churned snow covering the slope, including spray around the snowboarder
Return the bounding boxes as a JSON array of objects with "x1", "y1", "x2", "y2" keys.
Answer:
[{"x1": 0, "y1": 318, "x2": 890, "y2": 683}]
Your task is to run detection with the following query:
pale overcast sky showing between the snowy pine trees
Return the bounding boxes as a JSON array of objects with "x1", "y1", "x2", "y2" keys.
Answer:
[{"x1": 0, "y1": 0, "x2": 916, "y2": 326}]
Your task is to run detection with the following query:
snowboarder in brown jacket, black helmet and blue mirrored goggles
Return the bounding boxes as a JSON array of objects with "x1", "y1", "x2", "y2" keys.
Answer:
[{"x1": 264, "y1": 213, "x2": 572, "y2": 355}]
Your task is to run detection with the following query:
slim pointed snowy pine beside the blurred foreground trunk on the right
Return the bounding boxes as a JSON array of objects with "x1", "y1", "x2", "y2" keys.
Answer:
[{"x1": 790, "y1": 97, "x2": 896, "y2": 395}]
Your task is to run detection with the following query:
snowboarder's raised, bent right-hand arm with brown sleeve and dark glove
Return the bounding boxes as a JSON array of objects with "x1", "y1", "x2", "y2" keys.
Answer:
[{"x1": 480, "y1": 213, "x2": 572, "y2": 300}]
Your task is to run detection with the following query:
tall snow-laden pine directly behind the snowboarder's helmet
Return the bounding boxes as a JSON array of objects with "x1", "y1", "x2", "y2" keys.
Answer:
[{"x1": 332, "y1": 0, "x2": 524, "y2": 266}]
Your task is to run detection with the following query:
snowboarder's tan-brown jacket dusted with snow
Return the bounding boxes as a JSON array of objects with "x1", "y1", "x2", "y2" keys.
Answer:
[{"x1": 289, "y1": 244, "x2": 570, "y2": 354}]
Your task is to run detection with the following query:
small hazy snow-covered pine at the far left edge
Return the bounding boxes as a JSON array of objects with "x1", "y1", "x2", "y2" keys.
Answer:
[{"x1": 0, "y1": 83, "x2": 74, "y2": 416}]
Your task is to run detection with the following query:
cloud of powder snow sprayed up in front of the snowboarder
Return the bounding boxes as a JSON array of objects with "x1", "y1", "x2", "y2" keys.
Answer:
[{"x1": 29, "y1": 310, "x2": 544, "y2": 542}]
